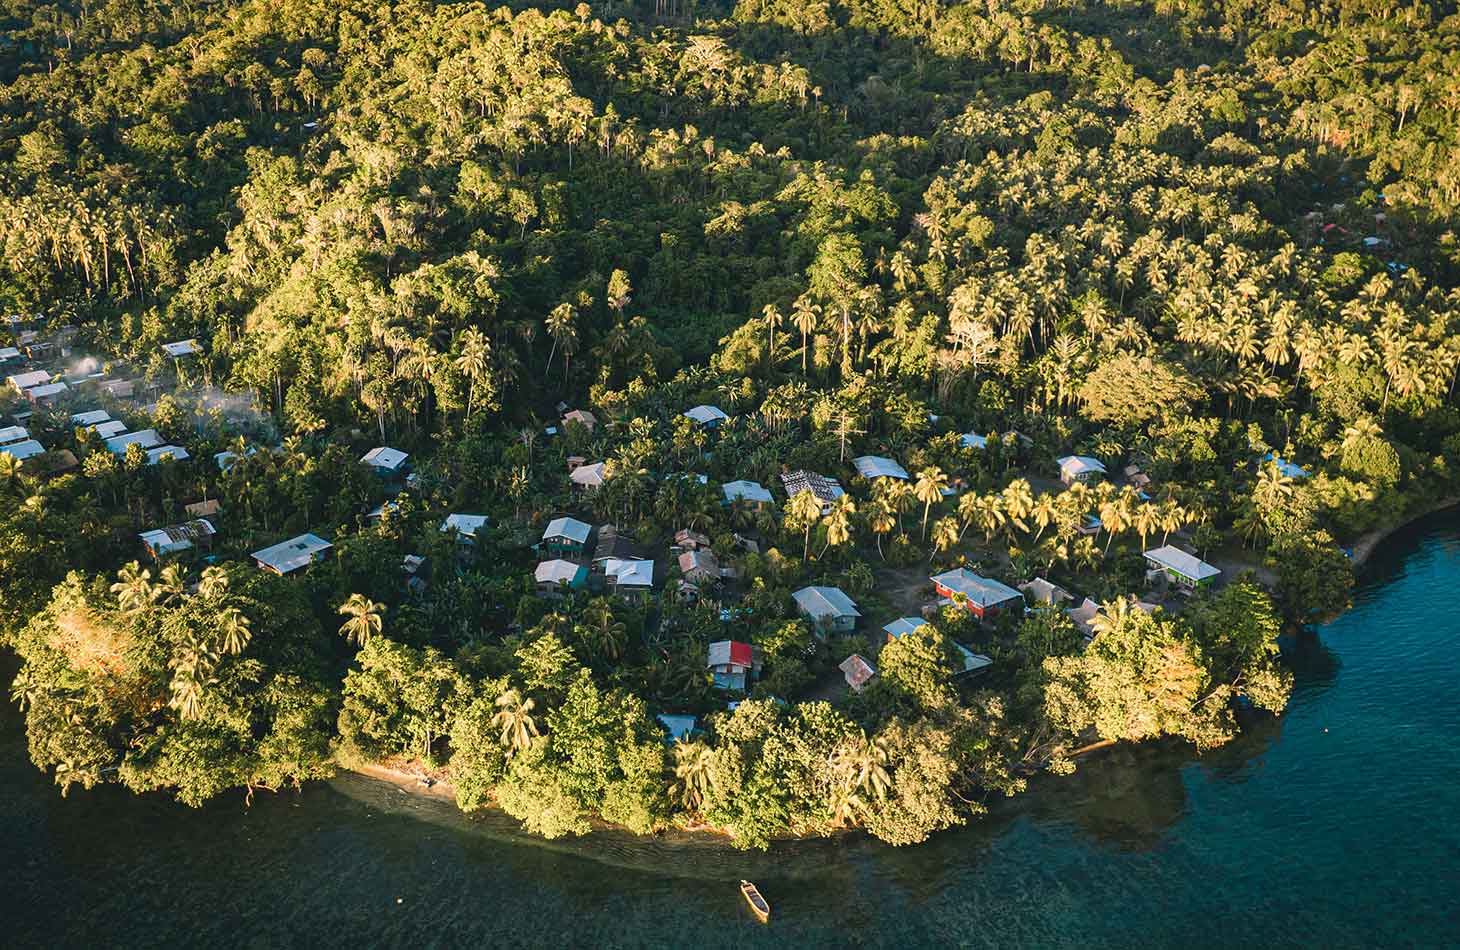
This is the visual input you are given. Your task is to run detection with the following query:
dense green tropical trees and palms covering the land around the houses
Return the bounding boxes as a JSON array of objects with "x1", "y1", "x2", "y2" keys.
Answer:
[{"x1": 0, "y1": 0, "x2": 1460, "y2": 848}]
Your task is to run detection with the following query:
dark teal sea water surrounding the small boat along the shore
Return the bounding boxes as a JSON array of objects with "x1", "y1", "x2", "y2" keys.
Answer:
[{"x1": 0, "y1": 514, "x2": 1460, "y2": 949}]
